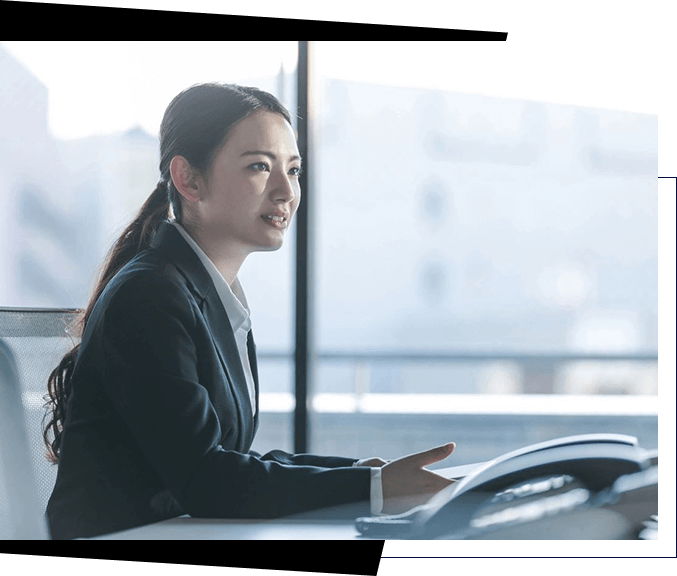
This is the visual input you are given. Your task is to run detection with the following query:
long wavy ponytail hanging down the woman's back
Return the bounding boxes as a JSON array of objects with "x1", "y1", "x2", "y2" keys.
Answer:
[{"x1": 42, "y1": 180, "x2": 170, "y2": 464}]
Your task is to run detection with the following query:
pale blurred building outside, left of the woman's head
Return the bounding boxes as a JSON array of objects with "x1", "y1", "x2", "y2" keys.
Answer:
[{"x1": 0, "y1": 46, "x2": 158, "y2": 307}]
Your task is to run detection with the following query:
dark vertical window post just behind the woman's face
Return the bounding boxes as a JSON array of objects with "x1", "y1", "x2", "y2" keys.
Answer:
[{"x1": 294, "y1": 41, "x2": 315, "y2": 454}]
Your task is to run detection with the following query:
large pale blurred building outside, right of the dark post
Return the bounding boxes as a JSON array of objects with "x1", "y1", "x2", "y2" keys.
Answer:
[{"x1": 316, "y1": 80, "x2": 658, "y2": 392}]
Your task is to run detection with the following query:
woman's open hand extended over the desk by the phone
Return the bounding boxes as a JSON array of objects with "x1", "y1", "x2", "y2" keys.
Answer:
[{"x1": 381, "y1": 442, "x2": 456, "y2": 514}]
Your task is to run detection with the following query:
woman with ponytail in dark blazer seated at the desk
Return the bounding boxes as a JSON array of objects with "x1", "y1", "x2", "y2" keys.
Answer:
[{"x1": 45, "y1": 84, "x2": 453, "y2": 538}]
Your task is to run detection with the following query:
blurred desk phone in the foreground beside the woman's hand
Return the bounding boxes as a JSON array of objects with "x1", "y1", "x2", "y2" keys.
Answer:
[{"x1": 356, "y1": 434, "x2": 658, "y2": 540}]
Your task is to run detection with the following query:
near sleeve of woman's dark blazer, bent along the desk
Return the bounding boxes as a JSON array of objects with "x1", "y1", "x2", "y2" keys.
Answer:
[{"x1": 97, "y1": 273, "x2": 370, "y2": 518}]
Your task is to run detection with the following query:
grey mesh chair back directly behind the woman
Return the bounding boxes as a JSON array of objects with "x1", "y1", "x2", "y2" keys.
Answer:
[{"x1": 0, "y1": 308, "x2": 79, "y2": 539}]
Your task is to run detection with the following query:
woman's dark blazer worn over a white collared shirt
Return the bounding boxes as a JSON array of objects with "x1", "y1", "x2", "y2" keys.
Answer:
[{"x1": 47, "y1": 223, "x2": 370, "y2": 538}]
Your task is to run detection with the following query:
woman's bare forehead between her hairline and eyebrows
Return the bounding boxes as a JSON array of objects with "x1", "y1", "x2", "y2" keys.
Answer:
[{"x1": 224, "y1": 110, "x2": 298, "y2": 157}]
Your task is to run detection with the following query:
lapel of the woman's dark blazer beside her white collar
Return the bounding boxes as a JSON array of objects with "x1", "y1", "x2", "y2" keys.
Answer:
[{"x1": 151, "y1": 222, "x2": 258, "y2": 451}]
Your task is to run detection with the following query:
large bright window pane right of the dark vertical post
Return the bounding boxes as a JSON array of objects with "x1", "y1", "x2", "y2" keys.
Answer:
[{"x1": 311, "y1": 42, "x2": 658, "y2": 456}]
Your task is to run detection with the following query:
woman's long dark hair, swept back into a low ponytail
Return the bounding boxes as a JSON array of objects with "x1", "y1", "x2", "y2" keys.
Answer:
[{"x1": 43, "y1": 83, "x2": 291, "y2": 463}]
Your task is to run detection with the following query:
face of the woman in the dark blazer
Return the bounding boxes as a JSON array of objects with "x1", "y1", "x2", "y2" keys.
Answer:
[{"x1": 189, "y1": 111, "x2": 301, "y2": 256}]
